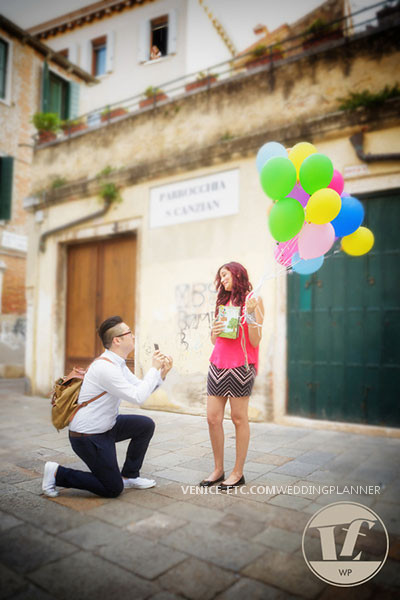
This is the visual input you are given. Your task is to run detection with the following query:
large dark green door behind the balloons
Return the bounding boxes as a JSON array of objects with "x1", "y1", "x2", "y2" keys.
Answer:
[{"x1": 287, "y1": 190, "x2": 400, "y2": 427}]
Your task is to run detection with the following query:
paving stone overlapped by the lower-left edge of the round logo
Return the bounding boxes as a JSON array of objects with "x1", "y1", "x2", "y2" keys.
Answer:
[{"x1": 242, "y1": 548, "x2": 325, "y2": 598}]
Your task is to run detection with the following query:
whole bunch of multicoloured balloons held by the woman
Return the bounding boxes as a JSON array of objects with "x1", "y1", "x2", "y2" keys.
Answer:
[{"x1": 256, "y1": 142, "x2": 374, "y2": 275}]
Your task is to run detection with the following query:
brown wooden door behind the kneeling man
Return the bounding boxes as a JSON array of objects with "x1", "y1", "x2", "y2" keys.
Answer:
[{"x1": 65, "y1": 235, "x2": 136, "y2": 372}]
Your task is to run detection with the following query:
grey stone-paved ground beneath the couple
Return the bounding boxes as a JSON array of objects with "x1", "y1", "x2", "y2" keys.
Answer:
[{"x1": 0, "y1": 380, "x2": 400, "y2": 600}]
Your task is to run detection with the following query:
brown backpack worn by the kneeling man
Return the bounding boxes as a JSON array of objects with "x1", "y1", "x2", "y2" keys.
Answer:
[{"x1": 51, "y1": 356, "x2": 112, "y2": 431}]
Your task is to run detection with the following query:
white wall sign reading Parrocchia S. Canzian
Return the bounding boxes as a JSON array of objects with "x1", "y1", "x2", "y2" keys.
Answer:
[{"x1": 150, "y1": 169, "x2": 239, "y2": 228}]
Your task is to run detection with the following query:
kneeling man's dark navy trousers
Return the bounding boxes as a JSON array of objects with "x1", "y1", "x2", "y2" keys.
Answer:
[{"x1": 56, "y1": 415, "x2": 155, "y2": 498}]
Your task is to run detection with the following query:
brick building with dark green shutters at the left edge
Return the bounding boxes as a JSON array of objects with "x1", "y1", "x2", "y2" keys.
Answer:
[{"x1": 0, "y1": 16, "x2": 93, "y2": 377}]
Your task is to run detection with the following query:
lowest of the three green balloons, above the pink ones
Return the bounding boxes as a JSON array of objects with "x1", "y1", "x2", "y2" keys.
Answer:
[{"x1": 268, "y1": 198, "x2": 304, "y2": 242}]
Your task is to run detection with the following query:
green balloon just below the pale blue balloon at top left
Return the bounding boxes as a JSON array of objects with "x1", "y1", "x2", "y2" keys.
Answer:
[{"x1": 260, "y1": 156, "x2": 297, "y2": 200}]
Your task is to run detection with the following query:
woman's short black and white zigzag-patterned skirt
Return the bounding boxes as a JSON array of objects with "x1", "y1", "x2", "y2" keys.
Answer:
[{"x1": 207, "y1": 363, "x2": 256, "y2": 398}]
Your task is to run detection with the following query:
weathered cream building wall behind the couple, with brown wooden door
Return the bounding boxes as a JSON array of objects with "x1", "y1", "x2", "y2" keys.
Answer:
[{"x1": 26, "y1": 17, "x2": 400, "y2": 431}]
